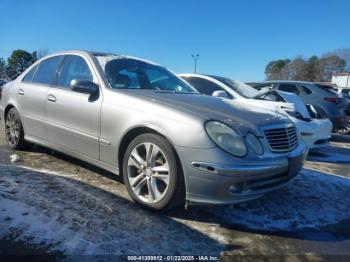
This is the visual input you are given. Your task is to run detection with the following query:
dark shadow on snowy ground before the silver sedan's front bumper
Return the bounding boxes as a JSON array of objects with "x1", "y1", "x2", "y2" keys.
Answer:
[{"x1": 168, "y1": 169, "x2": 350, "y2": 242}]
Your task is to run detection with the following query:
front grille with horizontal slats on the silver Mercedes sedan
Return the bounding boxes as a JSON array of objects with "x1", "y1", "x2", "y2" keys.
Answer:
[{"x1": 264, "y1": 125, "x2": 298, "y2": 152}]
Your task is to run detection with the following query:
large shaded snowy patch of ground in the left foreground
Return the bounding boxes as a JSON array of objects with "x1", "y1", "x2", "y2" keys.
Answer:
[{"x1": 0, "y1": 165, "x2": 224, "y2": 255}]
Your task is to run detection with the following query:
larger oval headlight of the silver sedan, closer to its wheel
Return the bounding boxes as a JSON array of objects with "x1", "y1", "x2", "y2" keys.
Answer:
[{"x1": 205, "y1": 121, "x2": 247, "y2": 157}]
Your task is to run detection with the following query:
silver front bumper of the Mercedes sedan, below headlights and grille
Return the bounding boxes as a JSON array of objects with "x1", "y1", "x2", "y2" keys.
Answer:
[{"x1": 176, "y1": 143, "x2": 307, "y2": 204}]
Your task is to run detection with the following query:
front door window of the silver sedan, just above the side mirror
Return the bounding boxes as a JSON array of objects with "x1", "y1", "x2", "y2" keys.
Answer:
[{"x1": 57, "y1": 55, "x2": 93, "y2": 89}]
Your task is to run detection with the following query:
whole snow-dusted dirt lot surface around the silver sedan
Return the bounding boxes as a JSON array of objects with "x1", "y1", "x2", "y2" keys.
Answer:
[{"x1": 0, "y1": 126, "x2": 350, "y2": 261}]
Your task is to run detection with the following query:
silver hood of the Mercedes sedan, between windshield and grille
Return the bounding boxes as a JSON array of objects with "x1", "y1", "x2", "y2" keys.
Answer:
[{"x1": 120, "y1": 90, "x2": 290, "y2": 134}]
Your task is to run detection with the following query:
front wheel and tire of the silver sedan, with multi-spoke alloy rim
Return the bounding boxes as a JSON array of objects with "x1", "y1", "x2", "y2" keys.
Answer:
[{"x1": 123, "y1": 134, "x2": 185, "y2": 211}]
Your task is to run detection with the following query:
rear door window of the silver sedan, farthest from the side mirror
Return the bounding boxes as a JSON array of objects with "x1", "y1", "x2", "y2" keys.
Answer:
[{"x1": 32, "y1": 56, "x2": 62, "y2": 85}]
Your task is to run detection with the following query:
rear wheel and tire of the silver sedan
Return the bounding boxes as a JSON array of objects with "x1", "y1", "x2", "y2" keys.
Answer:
[{"x1": 5, "y1": 108, "x2": 28, "y2": 150}]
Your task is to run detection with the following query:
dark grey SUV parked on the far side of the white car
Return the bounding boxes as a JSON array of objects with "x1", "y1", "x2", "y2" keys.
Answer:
[{"x1": 254, "y1": 80, "x2": 347, "y2": 131}]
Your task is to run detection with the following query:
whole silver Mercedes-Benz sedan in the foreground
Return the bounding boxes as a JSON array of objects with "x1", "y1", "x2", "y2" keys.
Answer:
[{"x1": 0, "y1": 51, "x2": 307, "y2": 210}]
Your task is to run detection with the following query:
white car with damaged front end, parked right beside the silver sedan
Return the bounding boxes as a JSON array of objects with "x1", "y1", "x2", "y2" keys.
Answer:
[{"x1": 179, "y1": 74, "x2": 332, "y2": 149}]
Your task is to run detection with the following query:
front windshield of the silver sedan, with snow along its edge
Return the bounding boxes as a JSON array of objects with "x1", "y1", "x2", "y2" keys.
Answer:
[{"x1": 96, "y1": 55, "x2": 197, "y2": 93}]
